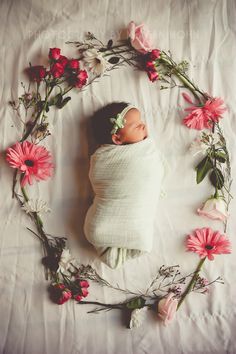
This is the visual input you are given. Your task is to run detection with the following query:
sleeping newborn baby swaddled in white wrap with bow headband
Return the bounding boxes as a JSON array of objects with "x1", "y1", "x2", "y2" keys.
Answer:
[{"x1": 84, "y1": 102, "x2": 164, "y2": 268}]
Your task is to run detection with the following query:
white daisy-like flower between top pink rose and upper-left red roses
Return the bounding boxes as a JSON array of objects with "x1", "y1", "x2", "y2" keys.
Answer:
[{"x1": 83, "y1": 48, "x2": 109, "y2": 75}]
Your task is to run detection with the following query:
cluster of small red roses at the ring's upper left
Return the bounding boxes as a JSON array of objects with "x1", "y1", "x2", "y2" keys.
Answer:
[{"x1": 27, "y1": 48, "x2": 88, "y2": 88}]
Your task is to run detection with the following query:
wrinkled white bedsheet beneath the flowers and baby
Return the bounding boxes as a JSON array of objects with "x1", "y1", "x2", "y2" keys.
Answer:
[{"x1": 0, "y1": 0, "x2": 236, "y2": 354}]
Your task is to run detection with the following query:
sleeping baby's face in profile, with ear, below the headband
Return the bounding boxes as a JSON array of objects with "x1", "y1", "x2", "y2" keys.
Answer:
[{"x1": 114, "y1": 108, "x2": 147, "y2": 144}]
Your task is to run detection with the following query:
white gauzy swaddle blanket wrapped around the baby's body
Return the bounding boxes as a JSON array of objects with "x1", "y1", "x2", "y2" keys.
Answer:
[{"x1": 84, "y1": 138, "x2": 165, "y2": 268}]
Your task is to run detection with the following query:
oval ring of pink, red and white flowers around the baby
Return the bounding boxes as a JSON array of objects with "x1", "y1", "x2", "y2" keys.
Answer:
[{"x1": 6, "y1": 22, "x2": 232, "y2": 328}]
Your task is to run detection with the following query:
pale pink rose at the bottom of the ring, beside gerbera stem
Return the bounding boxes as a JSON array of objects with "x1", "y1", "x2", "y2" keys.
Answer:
[{"x1": 157, "y1": 293, "x2": 178, "y2": 326}]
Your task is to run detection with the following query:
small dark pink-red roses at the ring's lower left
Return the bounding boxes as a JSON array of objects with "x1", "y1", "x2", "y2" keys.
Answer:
[{"x1": 49, "y1": 279, "x2": 89, "y2": 305}]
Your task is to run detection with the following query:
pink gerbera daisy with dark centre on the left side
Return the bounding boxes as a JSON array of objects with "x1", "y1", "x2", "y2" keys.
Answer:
[{"x1": 6, "y1": 141, "x2": 54, "y2": 187}]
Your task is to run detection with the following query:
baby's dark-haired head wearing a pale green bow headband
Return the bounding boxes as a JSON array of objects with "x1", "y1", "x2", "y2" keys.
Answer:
[{"x1": 92, "y1": 102, "x2": 147, "y2": 145}]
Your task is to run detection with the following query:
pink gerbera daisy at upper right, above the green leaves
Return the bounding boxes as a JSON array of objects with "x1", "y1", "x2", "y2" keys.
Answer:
[{"x1": 183, "y1": 93, "x2": 226, "y2": 130}]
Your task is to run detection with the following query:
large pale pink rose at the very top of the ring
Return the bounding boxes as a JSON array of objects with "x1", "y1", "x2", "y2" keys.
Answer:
[{"x1": 128, "y1": 21, "x2": 153, "y2": 54}]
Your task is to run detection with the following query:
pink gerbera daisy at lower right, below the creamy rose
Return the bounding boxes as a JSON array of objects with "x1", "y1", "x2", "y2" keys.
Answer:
[{"x1": 186, "y1": 227, "x2": 231, "y2": 261}]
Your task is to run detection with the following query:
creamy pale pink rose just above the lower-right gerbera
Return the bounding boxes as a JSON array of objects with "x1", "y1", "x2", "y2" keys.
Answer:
[{"x1": 197, "y1": 197, "x2": 229, "y2": 222}]
